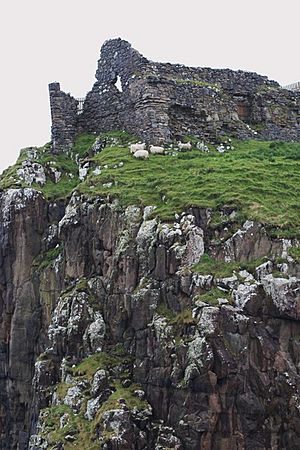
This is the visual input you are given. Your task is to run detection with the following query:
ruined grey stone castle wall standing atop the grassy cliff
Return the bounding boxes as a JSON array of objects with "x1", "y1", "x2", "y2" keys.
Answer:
[{"x1": 49, "y1": 39, "x2": 300, "y2": 152}]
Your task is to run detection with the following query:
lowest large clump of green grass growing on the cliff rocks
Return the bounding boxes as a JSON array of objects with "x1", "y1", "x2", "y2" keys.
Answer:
[{"x1": 40, "y1": 344, "x2": 149, "y2": 450}]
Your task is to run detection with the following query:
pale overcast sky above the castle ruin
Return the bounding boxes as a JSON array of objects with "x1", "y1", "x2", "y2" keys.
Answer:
[{"x1": 0, "y1": 0, "x2": 300, "y2": 172}]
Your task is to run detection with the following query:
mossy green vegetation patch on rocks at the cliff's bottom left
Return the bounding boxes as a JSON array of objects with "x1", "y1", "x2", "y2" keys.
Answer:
[{"x1": 37, "y1": 345, "x2": 150, "y2": 450}]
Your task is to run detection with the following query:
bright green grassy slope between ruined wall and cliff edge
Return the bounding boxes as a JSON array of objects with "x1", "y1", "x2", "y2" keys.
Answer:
[{"x1": 0, "y1": 132, "x2": 300, "y2": 237}]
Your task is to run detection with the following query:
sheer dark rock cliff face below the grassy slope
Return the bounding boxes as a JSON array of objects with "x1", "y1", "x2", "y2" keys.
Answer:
[{"x1": 0, "y1": 188, "x2": 300, "y2": 450}]
